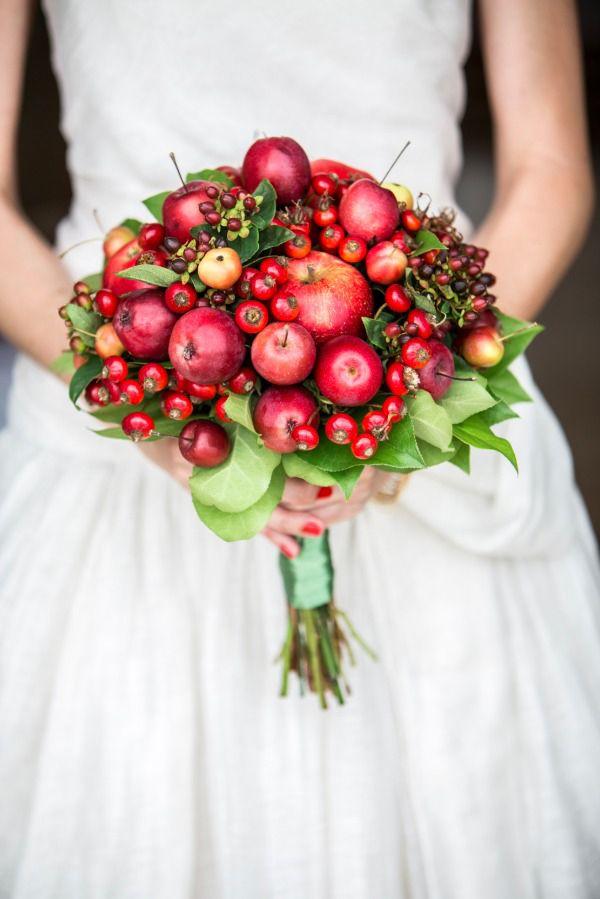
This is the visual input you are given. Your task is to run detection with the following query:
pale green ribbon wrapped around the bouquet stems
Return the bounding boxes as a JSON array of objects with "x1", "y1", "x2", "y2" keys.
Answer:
[{"x1": 279, "y1": 531, "x2": 333, "y2": 609}]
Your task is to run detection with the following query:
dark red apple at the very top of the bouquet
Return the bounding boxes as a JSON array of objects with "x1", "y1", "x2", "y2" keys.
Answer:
[{"x1": 242, "y1": 137, "x2": 311, "y2": 206}]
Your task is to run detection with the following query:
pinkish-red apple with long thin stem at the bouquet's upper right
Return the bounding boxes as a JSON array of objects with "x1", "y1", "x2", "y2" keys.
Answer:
[{"x1": 339, "y1": 178, "x2": 400, "y2": 241}]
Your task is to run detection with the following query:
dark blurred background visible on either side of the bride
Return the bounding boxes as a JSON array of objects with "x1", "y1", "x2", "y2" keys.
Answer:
[{"x1": 0, "y1": 0, "x2": 600, "y2": 534}]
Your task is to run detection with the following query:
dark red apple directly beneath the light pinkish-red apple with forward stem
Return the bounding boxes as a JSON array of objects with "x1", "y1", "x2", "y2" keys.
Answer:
[{"x1": 254, "y1": 387, "x2": 318, "y2": 453}]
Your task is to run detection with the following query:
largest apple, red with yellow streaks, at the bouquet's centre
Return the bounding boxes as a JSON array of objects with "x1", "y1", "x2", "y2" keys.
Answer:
[{"x1": 281, "y1": 251, "x2": 373, "y2": 344}]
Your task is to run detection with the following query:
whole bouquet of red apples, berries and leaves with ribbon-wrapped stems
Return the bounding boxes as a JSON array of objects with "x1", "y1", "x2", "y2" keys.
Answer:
[{"x1": 57, "y1": 137, "x2": 540, "y2": 706}]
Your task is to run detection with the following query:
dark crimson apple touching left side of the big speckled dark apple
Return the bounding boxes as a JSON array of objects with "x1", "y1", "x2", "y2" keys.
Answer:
[{"x1": 113, "y1": 284, "x2": 177, "y2": 361}]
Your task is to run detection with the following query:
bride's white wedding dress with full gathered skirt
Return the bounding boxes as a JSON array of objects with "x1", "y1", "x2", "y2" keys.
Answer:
[{"x1": 0, "y1": 0, "x2": 600, "y2": 899}]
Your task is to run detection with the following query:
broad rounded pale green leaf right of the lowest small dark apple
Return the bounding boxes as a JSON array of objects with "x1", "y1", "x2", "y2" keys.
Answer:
[{"x1": 190, "y1": 425, "x2": 280, "y2": 512}]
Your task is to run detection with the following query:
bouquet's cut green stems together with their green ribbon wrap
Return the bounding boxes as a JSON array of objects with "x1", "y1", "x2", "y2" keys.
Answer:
[{"x1": 280, "y1": 531, "x2": 376, "y2": 709}]
